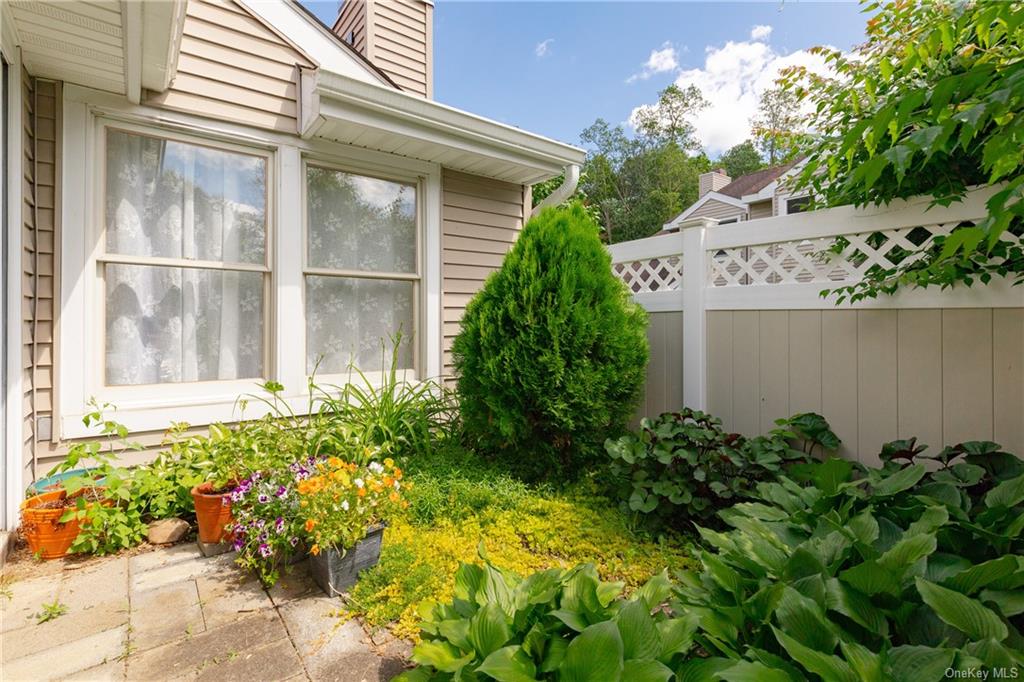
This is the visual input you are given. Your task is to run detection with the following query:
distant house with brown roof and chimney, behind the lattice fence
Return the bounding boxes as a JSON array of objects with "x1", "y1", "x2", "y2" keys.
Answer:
[{"x1": 662, "y1": 161, "x2": 807, "y2": 233}]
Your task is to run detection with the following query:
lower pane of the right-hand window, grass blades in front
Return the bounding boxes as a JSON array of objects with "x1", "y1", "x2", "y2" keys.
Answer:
[{"x1": 306, "y1": 276, "x2": 414, "y2": 374}]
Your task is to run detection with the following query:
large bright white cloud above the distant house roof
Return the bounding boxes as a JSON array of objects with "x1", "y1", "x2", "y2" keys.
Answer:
[{"x1": 630, "y1": 40, "x2": 826, "y2": 157}]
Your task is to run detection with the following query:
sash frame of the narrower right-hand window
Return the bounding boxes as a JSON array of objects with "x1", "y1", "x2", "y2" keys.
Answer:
[{"x1": 302, "y1": 156, "x2": 426, "y2": 386}]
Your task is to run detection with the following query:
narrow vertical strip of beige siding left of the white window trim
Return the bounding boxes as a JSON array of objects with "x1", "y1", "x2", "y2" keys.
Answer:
[{"x1": 22, "y1": 72, "x2": 60, "y2": 480}]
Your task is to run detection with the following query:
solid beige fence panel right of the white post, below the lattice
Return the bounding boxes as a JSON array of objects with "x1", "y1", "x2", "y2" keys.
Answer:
[{"x1": 704, "y1": 308, "x2": 1024, "y2": 464}]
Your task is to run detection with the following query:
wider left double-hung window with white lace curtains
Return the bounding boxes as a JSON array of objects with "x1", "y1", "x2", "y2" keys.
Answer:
[{"x1": 98, "y1": 127, "x2": 269, "y2": 387}]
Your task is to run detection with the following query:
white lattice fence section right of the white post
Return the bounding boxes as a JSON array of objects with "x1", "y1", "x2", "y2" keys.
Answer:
[{"x1": 708, "y1": 222, "x2": 962, "y2": 287}]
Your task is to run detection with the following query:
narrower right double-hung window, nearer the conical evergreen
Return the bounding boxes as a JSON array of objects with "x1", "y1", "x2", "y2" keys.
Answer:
[{"x1": 304, "y1": 163, "x2": 420, "y2": 377}]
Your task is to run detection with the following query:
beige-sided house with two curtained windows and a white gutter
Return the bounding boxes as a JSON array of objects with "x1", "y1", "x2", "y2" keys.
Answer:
[{"x1": 0, "y1": 0, "x2": 584, "y2": 528}]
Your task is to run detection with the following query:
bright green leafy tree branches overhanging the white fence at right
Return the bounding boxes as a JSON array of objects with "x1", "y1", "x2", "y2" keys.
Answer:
[{"x1": 782, "y1": 2, "x2": 1024, "y2": 300}]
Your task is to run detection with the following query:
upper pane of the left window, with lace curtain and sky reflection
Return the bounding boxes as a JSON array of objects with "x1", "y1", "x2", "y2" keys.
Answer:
[{"x1": 106, "y1": 130, "x2": 266, "y2": 263}]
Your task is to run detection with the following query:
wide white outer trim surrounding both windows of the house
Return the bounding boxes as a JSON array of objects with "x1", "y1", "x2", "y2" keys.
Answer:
[{"x1": 54, "y1": 86, "x2": 441, "y2": 438}]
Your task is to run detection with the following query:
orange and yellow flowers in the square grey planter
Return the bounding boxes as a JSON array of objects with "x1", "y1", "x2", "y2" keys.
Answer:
[{"x1": 298, "y1": 450, "x2": 412, "y2": 554}]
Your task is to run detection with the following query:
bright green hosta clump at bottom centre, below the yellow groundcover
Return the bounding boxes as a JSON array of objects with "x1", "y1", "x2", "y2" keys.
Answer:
[{"x1": 398, "y1": 562, "x2": 696, "y2": 682}]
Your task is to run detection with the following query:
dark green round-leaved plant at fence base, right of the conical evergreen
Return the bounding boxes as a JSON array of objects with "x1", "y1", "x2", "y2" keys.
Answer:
[{"x1": 604, "y1": 408, "x2": 839, "y2": 527}]
